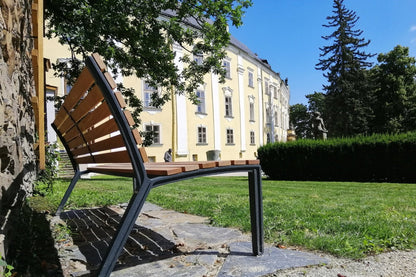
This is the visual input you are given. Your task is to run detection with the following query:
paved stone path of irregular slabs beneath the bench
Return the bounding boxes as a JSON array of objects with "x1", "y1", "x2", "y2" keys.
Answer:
[{"x1": 51, "y1": 203, "x2": 327, "y2": 277}]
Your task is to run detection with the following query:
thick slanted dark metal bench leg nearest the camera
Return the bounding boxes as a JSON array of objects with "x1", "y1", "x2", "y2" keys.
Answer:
[{"x1": 98, "y1": 178, "x2": 151, "y2": 277}]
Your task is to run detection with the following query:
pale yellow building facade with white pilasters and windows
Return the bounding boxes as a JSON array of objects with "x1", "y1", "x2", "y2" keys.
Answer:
[{"x1": 44, "y1": 31, "x2": 290, "y2": 162}]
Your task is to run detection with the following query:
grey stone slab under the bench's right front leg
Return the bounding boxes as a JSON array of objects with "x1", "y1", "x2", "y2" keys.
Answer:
[{"x1": 218, "y1": 242, "x2": 328, "y2": 277}]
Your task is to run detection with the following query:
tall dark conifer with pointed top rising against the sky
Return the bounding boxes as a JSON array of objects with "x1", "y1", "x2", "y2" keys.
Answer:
[{"x1": 315, "y1": 0, "x2": 374, "y2": 137}]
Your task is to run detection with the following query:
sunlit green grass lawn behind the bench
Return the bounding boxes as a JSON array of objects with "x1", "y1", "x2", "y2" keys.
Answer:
[{"x1": 30, "y1": 177, "x2": 416, "y2": 258}]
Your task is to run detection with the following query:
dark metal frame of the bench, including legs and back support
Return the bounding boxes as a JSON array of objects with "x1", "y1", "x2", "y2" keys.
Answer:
[{"x1": 53, "y1": 56, "x2": 264, "y2": 276}]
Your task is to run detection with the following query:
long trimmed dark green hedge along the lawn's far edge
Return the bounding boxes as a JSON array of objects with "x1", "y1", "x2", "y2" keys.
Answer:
[{"x1": 258, "y1": 132, "x2": 416, "y2": 182}]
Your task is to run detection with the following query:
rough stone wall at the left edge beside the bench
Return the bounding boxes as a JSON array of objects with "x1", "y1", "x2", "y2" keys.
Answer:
[{"x1": 0, "y1": 0, "x2": 36, "y2": 254}]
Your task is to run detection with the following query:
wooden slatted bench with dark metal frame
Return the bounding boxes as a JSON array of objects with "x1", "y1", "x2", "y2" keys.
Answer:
[{"x1": 52, "y1": 54, "x2": 263, "y2": 276}]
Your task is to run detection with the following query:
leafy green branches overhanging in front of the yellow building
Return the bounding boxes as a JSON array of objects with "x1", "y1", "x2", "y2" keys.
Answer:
[{"x1": 45, "y1": 0, "x2": 251, "y2": 109}]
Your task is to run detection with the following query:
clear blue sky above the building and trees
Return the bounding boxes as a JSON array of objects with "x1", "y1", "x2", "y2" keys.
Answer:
[{"x1": 230, "y1": 0, "x2": 416, "y2": 105}]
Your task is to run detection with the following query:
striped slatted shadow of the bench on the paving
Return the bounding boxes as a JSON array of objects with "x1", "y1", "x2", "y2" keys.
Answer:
[{"x1": 60, "y1": 207, "x2": 182, "y2": 272}]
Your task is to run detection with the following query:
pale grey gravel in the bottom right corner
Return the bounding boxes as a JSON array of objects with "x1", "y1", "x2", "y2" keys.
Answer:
[{"x1": 265, "y1": 250, "x2": 416, "y2": 277}]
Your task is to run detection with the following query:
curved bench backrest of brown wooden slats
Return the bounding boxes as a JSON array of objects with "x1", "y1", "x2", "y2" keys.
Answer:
[{"x1": 52, "y1": 54, "x2": 148, "y2": 179}]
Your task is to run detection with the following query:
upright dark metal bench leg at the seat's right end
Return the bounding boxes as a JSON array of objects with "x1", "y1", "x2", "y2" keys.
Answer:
[{"x1": 248, "y1": 166, "x2": 264, "y2": 256}]
